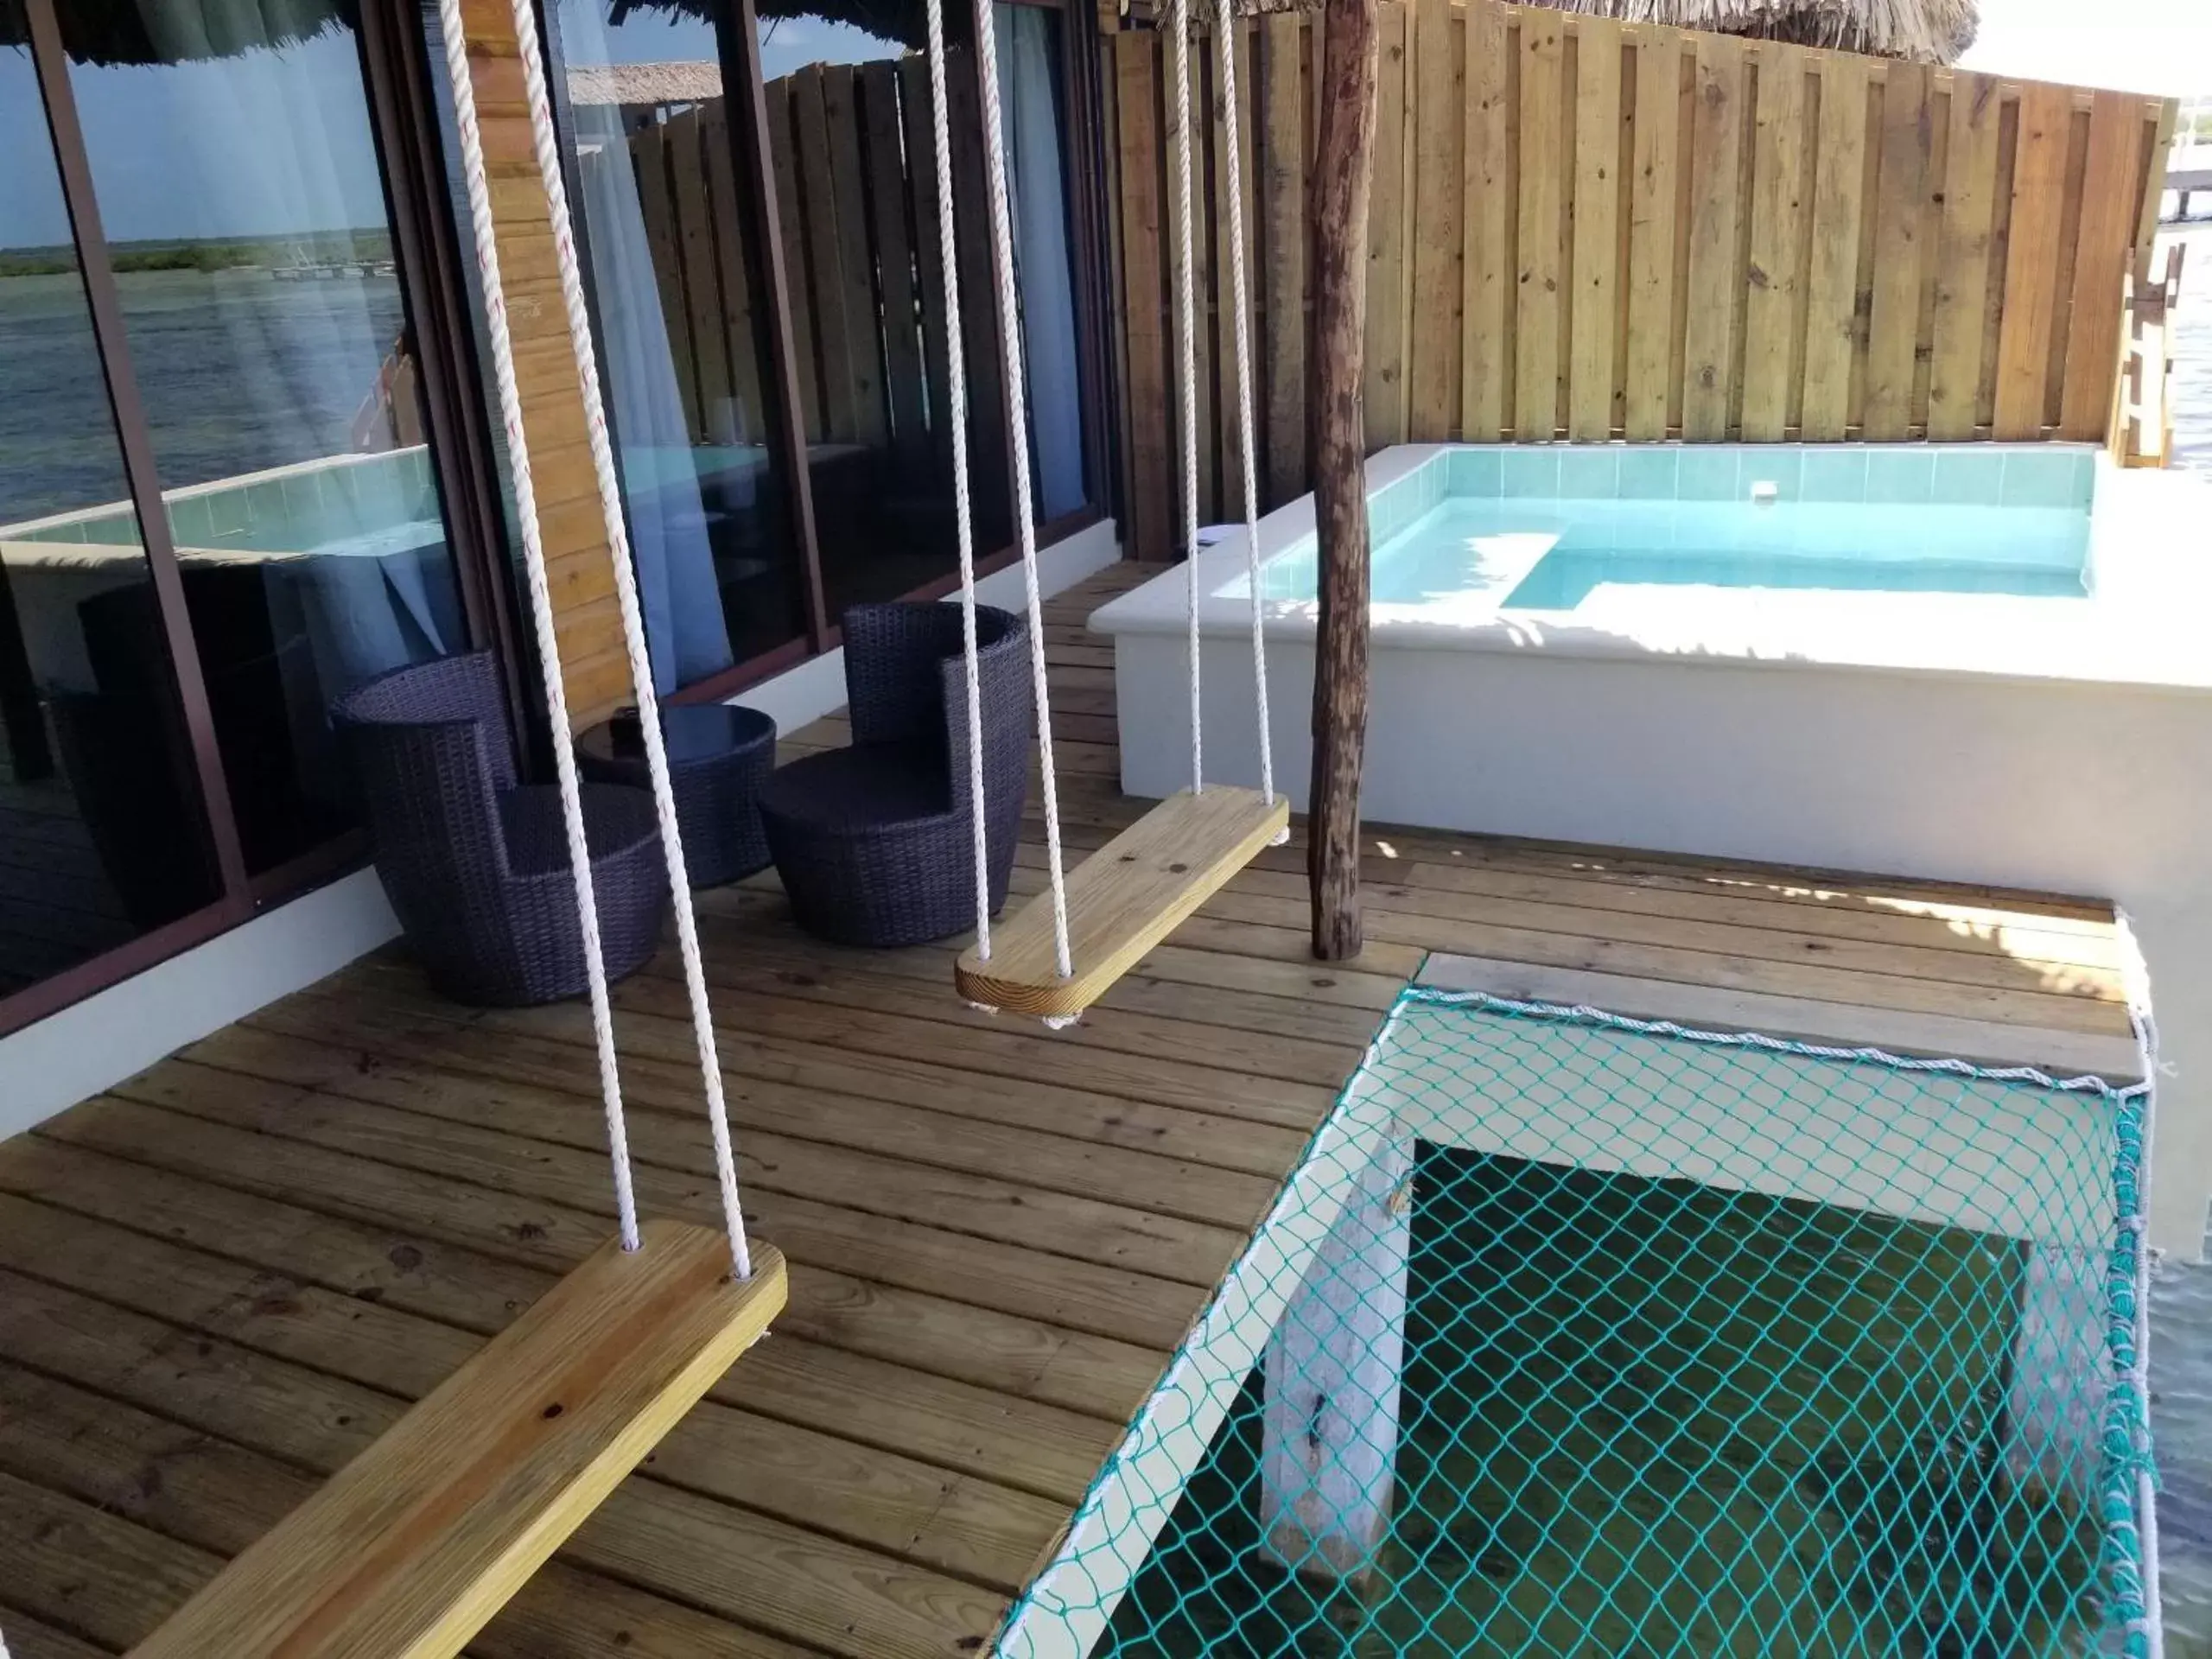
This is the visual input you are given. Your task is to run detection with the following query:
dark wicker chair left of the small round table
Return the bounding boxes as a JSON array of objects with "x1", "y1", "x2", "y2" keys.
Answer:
[{"x1": 332, "y1": 652, "x2": 668, "y2": 1007}]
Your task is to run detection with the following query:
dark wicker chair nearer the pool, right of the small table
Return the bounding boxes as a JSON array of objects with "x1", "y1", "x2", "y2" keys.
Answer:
[{"x1": 761, "y1": 604, "x2": 1028, "y2": 944}]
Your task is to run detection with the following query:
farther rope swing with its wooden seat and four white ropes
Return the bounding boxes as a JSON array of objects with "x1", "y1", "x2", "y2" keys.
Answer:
[{"x1": 946, "y1": 0, "x2": 1289, "y2": 1027}]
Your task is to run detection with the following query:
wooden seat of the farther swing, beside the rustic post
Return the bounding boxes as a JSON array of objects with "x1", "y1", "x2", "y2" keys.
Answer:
[{"x1": 953, "y1": 783, "x2": 1289, "y2": 1018}]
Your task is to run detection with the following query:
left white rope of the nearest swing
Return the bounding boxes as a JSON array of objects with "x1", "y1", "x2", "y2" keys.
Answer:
[{"x1": 438, "y1": 0, "x2": 639, "y2": 1249}]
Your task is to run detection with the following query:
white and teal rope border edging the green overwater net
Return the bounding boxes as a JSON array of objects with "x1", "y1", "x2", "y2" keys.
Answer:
[{"x1": 988, "y1": 982, "x2": 2165, "y2": 1659}]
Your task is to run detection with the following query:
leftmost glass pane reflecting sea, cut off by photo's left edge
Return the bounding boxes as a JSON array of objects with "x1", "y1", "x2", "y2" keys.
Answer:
[{"x1": 0, "y1": 47, "x2": 217, "y2": 995}]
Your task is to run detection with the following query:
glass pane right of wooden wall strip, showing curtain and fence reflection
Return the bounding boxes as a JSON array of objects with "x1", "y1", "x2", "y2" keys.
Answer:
[{"x1": 560, "y1": 0, "x2": 805, "y2": 692}]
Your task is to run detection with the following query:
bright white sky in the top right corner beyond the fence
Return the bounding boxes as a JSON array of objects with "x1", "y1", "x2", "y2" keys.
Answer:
[{"x1": 1960, "y1": 0, "x2": 2212, "y2": 98}]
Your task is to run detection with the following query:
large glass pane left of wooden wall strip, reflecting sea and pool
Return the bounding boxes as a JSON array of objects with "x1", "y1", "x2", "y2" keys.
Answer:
[{"x1": 71, "y1": 0, "x2": 467, "y2": 872}]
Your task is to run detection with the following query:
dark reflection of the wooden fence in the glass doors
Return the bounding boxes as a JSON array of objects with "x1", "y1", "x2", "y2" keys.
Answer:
[{"x1": 626, "y1": 51, "x2": 1002, "y2": 473}]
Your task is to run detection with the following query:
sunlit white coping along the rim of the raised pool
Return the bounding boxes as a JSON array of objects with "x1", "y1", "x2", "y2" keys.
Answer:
[{"x1": 1090, "y1": 445, "x2": 2212, "y2": 692}]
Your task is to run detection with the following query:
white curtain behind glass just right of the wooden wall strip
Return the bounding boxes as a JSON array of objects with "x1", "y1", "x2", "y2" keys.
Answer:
[{"x1": 560, "y1": 0, "x2": 732, "y2": 695}]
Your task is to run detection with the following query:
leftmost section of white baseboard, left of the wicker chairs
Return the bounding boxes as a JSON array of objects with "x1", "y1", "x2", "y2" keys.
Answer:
[{"x1": 0, "y1": 869, "x2": 400, "y2": 1139}]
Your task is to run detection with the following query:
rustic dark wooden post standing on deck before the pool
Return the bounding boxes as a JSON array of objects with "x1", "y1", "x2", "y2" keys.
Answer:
[{"x1": 1305, "y1": 0, "x2": 1376, "y2": 963}]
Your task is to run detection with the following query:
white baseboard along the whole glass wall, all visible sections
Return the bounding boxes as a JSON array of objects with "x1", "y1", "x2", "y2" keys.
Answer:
[{"x1": 0, "y1": 520, "x2": 1122, "y2": 1139}]
